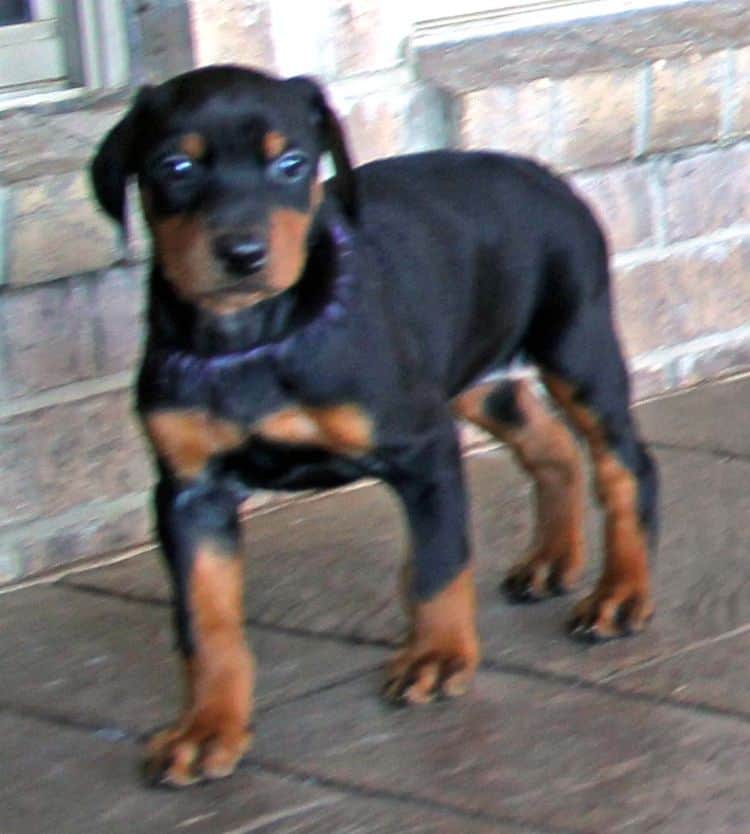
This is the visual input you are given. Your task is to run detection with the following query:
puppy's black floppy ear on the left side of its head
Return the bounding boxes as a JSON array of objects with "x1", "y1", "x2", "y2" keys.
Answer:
[{"x1": 90, "y1": 87, "x2": 151, "y2": 242}]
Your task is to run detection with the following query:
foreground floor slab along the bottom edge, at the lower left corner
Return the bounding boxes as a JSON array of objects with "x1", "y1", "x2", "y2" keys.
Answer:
[{"x1": 0, "y1": 714, "x2": 532, "y2": 834}]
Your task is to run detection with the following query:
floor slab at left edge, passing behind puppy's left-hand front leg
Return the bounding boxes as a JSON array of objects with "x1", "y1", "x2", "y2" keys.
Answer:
[{"x1": 0, "y1": 587, "x2": 382, "y2": 732}]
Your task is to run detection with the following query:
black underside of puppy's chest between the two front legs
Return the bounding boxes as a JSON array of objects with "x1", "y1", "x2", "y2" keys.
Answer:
[{"x1": 219, "y1": 439, "x2": 378, "y2": 490}]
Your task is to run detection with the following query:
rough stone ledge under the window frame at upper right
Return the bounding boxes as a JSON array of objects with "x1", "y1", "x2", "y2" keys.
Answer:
[{"x1": 409, "y1": 0, "x2": 750, "y2": 94}]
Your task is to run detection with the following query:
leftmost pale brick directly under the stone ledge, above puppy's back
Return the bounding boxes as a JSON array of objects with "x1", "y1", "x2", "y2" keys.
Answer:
[{"x1": 461, "y1": 80, "x2": 552, "y2": 159}]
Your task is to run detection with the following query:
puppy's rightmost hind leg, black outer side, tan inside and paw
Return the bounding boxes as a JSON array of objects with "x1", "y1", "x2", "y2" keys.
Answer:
[{"x1": 530, "y1": 284, "x2": 658, "y2": 640}]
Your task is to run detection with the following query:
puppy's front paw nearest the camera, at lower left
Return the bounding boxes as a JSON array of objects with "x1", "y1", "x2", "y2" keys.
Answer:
[{"x1": 143, "y1": 719, "x2": 252, "y2": 788}]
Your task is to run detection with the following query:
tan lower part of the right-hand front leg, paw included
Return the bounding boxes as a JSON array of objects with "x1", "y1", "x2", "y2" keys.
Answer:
[{"x1": 383, "y1": 567, "x2": 479, "y2": 704}]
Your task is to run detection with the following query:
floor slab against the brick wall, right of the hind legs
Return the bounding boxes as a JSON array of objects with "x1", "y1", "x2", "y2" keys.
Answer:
[{"x1": 636, "y1": 375, "x2": 750, "y2": 456}]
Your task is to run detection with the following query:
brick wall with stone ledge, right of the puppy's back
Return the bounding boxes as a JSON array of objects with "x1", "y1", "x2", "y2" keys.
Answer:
[{"x1": 415, "y1": 0, "x2": 750, "y2": 398}]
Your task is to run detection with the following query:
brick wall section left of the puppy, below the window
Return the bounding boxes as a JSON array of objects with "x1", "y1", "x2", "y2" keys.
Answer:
[{"x1": 0, "y1": 0, "x2": 197, "y2": 585}]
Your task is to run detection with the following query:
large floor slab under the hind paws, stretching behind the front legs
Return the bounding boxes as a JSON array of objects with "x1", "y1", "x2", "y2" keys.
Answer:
[{"x1": 64, "y1": 451, "x2": 750, "y2": 692}]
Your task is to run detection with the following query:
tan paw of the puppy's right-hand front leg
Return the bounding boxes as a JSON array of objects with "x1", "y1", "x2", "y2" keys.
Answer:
[{"x1": 383, "y1": 647, "x2": 479, "y2": 704}]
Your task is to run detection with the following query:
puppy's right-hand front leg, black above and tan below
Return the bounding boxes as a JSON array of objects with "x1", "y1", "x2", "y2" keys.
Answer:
[{"x1": 384, "y1": 420, "x2": 479, "y2": 704}]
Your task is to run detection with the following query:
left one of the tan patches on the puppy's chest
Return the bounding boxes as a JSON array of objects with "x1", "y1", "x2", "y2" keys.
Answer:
[{"x1": 145, "y1": 410, "x2": 247, "y2": 479}]
